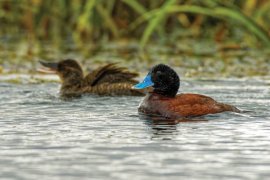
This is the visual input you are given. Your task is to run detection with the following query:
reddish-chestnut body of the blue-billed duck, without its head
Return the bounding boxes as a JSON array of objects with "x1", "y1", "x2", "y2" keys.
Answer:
[{"x1": 139, "y1": 93, "x2": 239, "y2": 118}]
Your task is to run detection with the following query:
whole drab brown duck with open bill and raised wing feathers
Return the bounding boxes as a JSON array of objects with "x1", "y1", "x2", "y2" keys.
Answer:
[{"x1": 39, "y1": 59, "x2": 144, "y2": 97}]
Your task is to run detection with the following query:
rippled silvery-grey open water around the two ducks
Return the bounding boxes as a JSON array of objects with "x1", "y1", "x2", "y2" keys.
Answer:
[{"x1": 0, "y1": 79, "x2": 270, "y2": 180}]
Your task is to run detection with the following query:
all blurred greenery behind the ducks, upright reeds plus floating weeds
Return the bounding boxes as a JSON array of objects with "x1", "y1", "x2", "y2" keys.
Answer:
[{"x1": 0, "y1": 0, "x2": 270, "y2": 76}]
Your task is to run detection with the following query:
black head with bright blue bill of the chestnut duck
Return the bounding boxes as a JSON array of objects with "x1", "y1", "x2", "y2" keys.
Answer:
[{"x1": 134, "y1": 64, "x2": 180, "y2": 97}]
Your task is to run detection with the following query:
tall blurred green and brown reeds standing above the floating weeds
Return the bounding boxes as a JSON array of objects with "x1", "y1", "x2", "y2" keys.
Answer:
[{"x1": 0, "y1": 0, "x2": 270, "y2": 47}]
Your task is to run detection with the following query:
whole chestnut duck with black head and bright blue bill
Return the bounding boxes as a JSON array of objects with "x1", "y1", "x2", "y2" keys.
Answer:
[{"x1": 133, "y1": 64, "x2": 240, "y2": 119}]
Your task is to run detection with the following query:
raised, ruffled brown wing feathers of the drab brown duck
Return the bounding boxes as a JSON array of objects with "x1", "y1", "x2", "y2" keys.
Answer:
[{"x1": 84, "y1": 63, "x2": 138, "y2": 86}]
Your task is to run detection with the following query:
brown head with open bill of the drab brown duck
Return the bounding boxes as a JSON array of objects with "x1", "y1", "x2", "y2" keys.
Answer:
[{"x1": 40, "y1": 59, "x2": 83, "y2": 85}]
